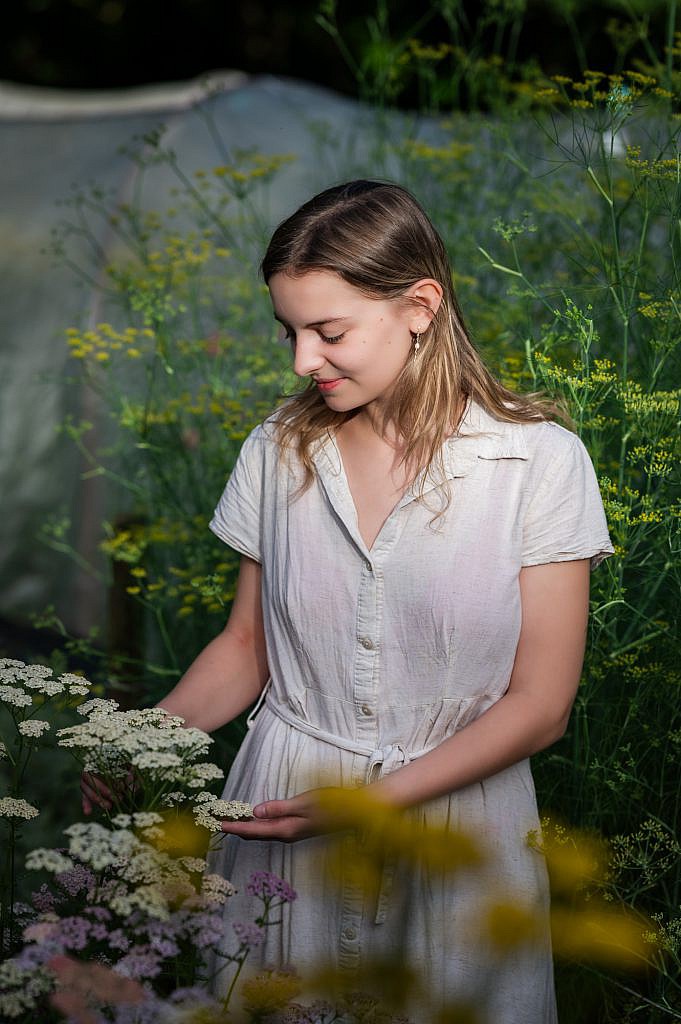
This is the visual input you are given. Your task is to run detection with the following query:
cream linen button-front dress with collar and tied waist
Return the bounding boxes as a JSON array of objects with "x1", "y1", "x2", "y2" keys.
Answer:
[{"x1": 204, "y1": 400, "x2": 612, "y2": 1024}]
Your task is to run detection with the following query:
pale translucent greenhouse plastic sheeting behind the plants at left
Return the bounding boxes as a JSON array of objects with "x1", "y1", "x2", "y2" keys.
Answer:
[{"x1": 0, "y1": 72, "x2": 391, "y2": 634}]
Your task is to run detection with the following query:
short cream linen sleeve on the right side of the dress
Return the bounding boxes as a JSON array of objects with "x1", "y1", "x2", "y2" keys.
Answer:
[{"x1": 521, "y1": 424, "x2": 613, "y2": 569}]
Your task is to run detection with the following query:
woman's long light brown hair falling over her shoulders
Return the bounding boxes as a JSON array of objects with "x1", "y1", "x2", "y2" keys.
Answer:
[{"x1": 261, "y1": 180, "x2": 564, "y2": 499}]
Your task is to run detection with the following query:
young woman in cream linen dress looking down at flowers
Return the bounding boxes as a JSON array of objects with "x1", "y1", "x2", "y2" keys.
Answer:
[{"x1": 83, "y1": 181, "x2": 612, "y2": 1024}]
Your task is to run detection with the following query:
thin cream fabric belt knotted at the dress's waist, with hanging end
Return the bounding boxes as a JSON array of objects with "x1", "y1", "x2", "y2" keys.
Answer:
[{"x1": 247, "y1": 684, "x2": 437, "y2": 925}]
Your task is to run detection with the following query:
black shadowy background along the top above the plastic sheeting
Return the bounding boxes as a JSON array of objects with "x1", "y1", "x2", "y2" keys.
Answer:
[{"x1": 0, "y1": 0, "x2": 670, "y2": 103}]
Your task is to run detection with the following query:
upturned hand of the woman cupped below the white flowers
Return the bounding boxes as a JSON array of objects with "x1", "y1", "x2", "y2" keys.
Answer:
[{"x1": 222, "y1": 790, "x2": 335, "y2": 843}]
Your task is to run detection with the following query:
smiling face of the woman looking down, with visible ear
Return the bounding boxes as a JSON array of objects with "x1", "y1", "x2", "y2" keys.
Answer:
[{"x1": 269, "y1": 270, "x2": 441, "y2": 413}]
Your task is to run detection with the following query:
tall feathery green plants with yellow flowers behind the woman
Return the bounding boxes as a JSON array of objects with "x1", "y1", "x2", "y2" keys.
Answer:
[{"x1": 23, "y1": 6, "x2": 681, "y2": 1024}]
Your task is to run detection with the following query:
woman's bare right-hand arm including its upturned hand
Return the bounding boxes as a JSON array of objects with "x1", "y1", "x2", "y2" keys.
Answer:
[{"x1": 224, "y1": 559, "x2": 589, "y2": 841}]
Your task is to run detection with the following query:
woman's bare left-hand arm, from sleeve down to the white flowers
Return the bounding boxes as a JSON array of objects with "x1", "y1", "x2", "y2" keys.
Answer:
[{"x1": 158, "y1": 556, "x2": 269, "y2": 732}]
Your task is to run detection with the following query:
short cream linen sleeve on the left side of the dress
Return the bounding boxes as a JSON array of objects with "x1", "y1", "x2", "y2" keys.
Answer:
[{"x1": 210, "y1": 426, "x2": 264, "y2": 562}]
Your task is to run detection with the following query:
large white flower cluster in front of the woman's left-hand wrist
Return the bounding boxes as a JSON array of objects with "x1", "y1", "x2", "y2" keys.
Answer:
[{"x1": 57, "y1": 698, "x2": 223, "y2": 786}]
